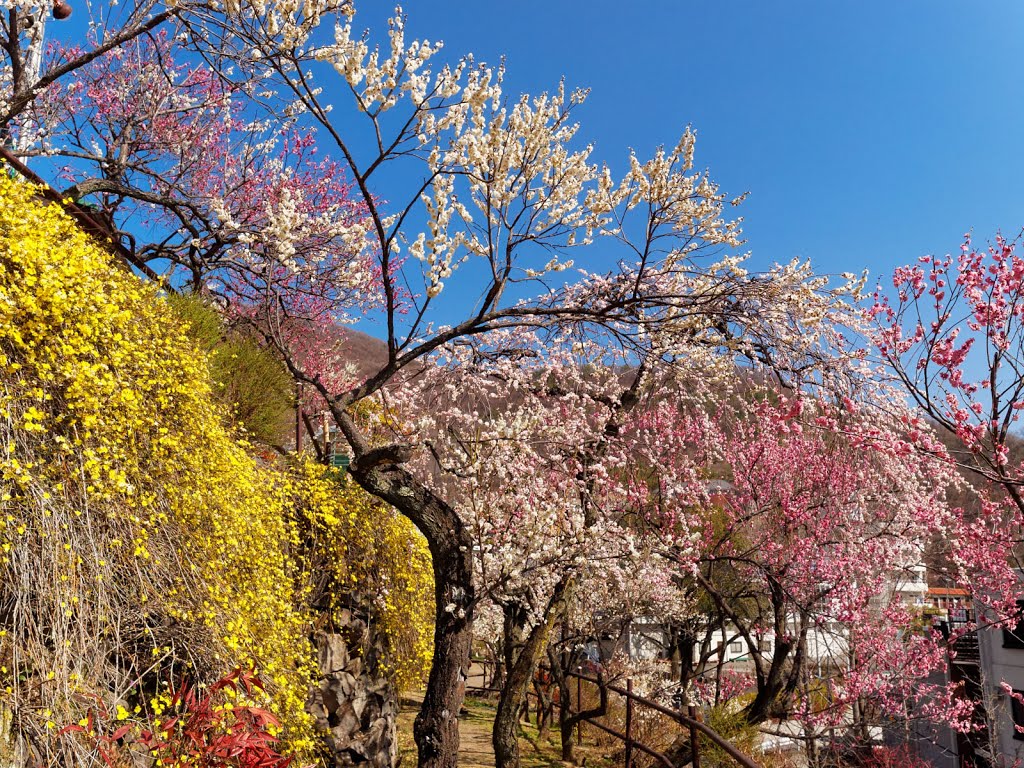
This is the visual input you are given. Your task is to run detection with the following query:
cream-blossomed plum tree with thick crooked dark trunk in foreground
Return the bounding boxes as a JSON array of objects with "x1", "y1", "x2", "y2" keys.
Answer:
[{"x1": 218, "y1": 4, "x2": 872, "y2": 766}]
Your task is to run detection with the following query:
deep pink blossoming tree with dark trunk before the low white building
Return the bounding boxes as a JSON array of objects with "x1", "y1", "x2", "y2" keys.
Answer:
[{"x1": 635, "y1": 385, "x2": 973, "y2": 757}]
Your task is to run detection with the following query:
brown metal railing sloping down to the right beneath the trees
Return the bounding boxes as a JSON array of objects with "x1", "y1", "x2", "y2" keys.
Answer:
[{"x1": 466, "y1": 658, "x2": 761, "y2": 768}]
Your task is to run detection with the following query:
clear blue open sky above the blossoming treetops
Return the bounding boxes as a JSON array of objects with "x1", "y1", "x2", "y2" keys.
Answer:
[{"x1": 366, "y1": 0, "x2": 1024, "y2": 286}]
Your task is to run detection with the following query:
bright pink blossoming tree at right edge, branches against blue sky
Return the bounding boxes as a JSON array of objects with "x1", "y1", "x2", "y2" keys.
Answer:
[{"x1": 868, "y1": 237, "x2": 1024, "y2": 614}]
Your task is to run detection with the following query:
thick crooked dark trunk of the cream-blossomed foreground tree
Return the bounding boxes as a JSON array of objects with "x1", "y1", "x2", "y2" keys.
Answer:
[{"x1": 349, "y1": 451, "x2": 474, "y2": 768}]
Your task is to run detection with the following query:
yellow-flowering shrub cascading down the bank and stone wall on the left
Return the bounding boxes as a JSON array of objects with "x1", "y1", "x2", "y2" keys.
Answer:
[{"x1": 0, "y1": 174, "x2": 432, "y2": 764}]
